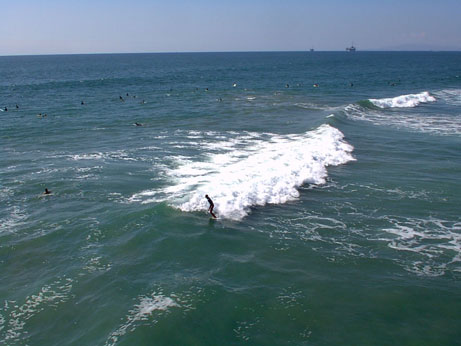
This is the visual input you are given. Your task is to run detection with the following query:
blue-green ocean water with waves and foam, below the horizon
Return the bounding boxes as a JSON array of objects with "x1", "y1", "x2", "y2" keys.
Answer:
[{"x1": 0, "y1": 52, "x2": 461, "y2": 345}]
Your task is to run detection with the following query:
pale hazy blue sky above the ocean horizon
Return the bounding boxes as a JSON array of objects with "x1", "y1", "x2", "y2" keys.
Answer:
[{"x1": 0, "y1": 0, "x2": 461, "y2": 55}]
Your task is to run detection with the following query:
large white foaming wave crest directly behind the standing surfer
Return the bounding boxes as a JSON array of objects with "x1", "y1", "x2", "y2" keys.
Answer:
[{"x1": 130, "y1": 124, "x2": 354, "y2": 220}]
